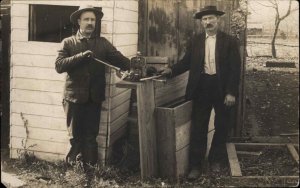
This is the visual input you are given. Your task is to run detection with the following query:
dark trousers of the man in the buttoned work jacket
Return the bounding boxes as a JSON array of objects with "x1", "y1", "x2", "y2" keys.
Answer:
[{"x1": 63, "y1": 100, "x2": 101, "y2": 165}]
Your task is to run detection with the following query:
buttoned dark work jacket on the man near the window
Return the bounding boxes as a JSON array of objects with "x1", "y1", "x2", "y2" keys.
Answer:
[{"x1": 55, "y1": 32, "x2": 130, "y2": 103}]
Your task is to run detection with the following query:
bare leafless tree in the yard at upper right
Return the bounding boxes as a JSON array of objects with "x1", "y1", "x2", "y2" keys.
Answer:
[{"x1": 259, "y1": 0, "x2": 299, "y2": 58}]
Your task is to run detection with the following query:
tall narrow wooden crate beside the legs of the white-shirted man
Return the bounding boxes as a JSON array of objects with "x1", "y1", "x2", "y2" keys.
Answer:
[{"x1": 155, "y1": 101, "x2": 192, "y2": 180}]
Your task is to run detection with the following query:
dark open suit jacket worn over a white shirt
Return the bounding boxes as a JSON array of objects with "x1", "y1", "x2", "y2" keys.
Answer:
[{"x1": 171, "y1": 31, "x2": 241, "y2": 100}]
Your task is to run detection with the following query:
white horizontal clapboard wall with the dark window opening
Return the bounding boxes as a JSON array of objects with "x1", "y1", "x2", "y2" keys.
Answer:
[{"x1": 10, "y1": 0, "x2": 138, "y2": 161}]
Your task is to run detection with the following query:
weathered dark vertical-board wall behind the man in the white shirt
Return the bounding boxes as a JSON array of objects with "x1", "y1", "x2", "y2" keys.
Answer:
[{"x1": 139, "y1": 0, "x2": 245, "y2": 135}]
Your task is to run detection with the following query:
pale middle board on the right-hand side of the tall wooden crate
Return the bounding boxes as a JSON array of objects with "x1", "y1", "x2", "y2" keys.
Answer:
[{"x1": 175, "y1": 121, "x2": 191, "y2": 151}]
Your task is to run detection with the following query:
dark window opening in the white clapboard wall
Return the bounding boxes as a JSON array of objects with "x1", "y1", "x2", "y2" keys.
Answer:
[{"x1": 29, "y1": 5, "x2": 78, "y2": 42}]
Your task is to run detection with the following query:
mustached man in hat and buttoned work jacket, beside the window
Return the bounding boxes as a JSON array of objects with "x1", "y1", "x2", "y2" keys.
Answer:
[{"x1": 55, "y1": 6, "x2": 129, "y2": 176}]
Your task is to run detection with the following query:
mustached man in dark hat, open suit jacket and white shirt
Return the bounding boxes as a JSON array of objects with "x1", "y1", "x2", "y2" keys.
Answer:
[{"x1": 161, "y1": 6, "x2": 241, "y2": 179}]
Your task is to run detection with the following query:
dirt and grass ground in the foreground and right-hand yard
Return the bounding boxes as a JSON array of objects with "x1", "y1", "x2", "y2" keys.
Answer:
[{"x1": 1, "y1": 57, "x2": 299, "y2": 187}]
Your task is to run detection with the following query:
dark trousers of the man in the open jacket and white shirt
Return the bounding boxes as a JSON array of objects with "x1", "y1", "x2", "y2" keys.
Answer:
[{"x1": 189, "y1": 74, "x2": 230, "y2": 168}]
